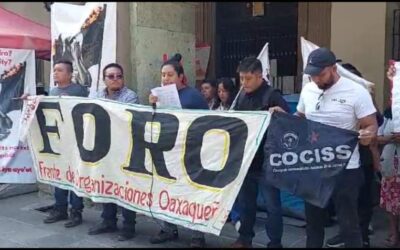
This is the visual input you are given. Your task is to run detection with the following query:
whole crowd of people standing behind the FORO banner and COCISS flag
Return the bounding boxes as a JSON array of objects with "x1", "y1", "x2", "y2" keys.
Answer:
[{"x1": 25, "y1": 48, "x2": 400, "y2": 248}]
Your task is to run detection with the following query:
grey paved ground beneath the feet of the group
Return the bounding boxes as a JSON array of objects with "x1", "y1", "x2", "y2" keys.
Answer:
[{"x1": 0, "y1": 192, "x2": 387, "y2": 248}]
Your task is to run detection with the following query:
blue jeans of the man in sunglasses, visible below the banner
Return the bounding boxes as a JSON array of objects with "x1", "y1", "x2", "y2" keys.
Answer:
[{"x1": 101, "y1": 203, "x2": 136, "y2": 229}]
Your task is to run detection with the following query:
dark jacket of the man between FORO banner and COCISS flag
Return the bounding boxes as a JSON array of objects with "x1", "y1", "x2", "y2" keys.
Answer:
[{"x1": 233, "y1": 81, "x2": 289, "y2": 172}]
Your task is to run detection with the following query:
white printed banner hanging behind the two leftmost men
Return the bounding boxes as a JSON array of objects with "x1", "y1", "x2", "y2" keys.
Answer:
[{"x1": 50, "y1": 2, "x2": 117, "y2": 95}]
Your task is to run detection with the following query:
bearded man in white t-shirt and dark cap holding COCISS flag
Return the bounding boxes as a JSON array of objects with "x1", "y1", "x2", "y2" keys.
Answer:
[{"x1": 296, "y1": 48, "x2": 377, "y2": 248}]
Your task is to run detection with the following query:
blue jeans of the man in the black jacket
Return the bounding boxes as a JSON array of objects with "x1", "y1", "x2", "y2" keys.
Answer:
[{"x1": 238, "y1": 172, "x2": 283, "y2": 246}]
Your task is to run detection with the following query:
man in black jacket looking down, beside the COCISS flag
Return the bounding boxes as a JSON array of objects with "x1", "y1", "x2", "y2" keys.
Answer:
[{"x1": 232, "y1": 57, "x2": 289, "y2": 247}]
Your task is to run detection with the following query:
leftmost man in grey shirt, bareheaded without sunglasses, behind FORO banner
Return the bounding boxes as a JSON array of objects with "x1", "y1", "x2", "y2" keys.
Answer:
[{"x1": 43, "y1": 60, "x2": 88, "y2": 227}]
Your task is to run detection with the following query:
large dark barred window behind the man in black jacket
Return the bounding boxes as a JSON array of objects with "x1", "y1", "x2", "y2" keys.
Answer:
[{"x1": 216, "y1": 2, "x2": 298, "y2": 92}]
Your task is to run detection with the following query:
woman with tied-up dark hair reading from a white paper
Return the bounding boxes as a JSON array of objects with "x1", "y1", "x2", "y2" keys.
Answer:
[{"x1": 149, "y1": 54, "x2": 208, "y2": 248}]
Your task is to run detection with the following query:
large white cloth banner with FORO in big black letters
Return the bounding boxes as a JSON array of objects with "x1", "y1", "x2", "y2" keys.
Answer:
[{"x1": 22, "y1": 97, "x2": 270, "y2": 235}]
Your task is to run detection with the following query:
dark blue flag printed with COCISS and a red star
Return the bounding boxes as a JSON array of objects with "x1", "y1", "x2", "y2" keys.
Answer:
[{"x1": 264, "y1": 112, "x2": 358, "y2": 207}]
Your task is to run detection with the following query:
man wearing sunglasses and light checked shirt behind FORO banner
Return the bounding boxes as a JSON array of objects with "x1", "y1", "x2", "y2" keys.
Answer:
[{"x1": 88, "y1": 63, "x2": 139, "y2": 241}]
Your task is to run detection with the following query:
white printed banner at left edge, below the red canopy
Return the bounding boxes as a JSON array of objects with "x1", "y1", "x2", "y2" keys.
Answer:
[{"x1": 0, "y1": 48, "x2": 36, "y2": 183}]
